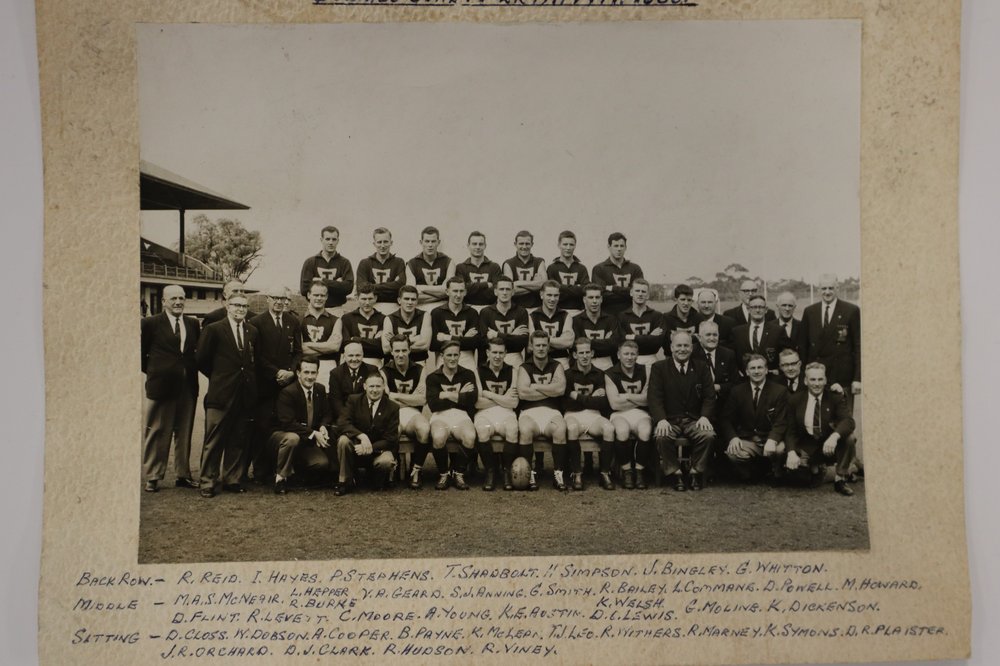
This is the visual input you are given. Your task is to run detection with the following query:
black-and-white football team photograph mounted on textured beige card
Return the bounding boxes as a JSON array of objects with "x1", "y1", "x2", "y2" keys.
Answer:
[{"x1": 139, "y1": 20, "x2": 869, "y2": 563}]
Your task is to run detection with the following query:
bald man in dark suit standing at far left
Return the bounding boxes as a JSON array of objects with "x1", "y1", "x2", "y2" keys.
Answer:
[{"x1": 141, "y1": 284, "x2": 200, "y2": 493}]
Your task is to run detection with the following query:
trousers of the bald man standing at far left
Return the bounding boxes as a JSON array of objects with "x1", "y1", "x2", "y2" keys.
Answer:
[{"x1": 142, "y1": 391, "x2": 195, "y2": 481}]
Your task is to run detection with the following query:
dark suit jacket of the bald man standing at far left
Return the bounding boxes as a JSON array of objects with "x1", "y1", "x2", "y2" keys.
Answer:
[{"x1": 140, "y1": 312, "x2": 201, "y2": 400}]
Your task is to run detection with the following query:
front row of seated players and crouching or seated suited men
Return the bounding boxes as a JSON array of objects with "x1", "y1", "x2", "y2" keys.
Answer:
[{"x1": 262, "y1": 331, "x2": 854, "y2": 495}]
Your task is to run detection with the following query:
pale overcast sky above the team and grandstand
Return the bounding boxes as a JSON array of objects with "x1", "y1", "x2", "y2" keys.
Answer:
[{"x1": 138, "y1": 21, "x2": 860, "y2": 287}]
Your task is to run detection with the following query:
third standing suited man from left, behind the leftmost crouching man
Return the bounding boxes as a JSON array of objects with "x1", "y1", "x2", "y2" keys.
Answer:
[{"x1": 243, "y1": 287, "x2": 302, "y2": 483}]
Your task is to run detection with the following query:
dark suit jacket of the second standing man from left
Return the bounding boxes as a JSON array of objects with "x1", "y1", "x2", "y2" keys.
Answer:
[{"x1": 195, "y1": 317, "x2": 258, "y2": 409}]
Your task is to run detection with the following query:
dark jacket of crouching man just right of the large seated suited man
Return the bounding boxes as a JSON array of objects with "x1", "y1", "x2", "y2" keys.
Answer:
[{"x1": 719, "y1": 381, "x2": 788, "y2": 442}]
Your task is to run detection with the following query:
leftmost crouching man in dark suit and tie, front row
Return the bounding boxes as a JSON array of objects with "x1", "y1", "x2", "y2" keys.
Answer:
[{"x1": 268, "y1": 356, "x2": 337, "y2": 495}]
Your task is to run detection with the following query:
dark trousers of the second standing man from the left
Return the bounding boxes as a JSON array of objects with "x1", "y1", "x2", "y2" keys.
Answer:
[{"x1": 201, "y1": 398, "x2": 253, "y2": 488}]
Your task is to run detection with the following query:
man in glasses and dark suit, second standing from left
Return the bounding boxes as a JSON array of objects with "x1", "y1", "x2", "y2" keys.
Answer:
[{"x1": 195, "y1": 295, "x2": 258, "y2": 497}]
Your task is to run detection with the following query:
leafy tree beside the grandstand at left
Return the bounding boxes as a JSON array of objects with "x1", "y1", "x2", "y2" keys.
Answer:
[{"x1": 185, "y1": 214, "x2": 263, "y2": 282}]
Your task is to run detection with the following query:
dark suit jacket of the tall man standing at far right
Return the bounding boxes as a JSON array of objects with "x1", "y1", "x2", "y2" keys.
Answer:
[{"x1": 801, "y1": 299, "x2": 861, "y2": 391}]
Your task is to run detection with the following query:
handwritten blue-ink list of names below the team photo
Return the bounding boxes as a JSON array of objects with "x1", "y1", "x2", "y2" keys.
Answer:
[{"x1": 67, "y1": 558, "x2": 947, "y2": 660}]
